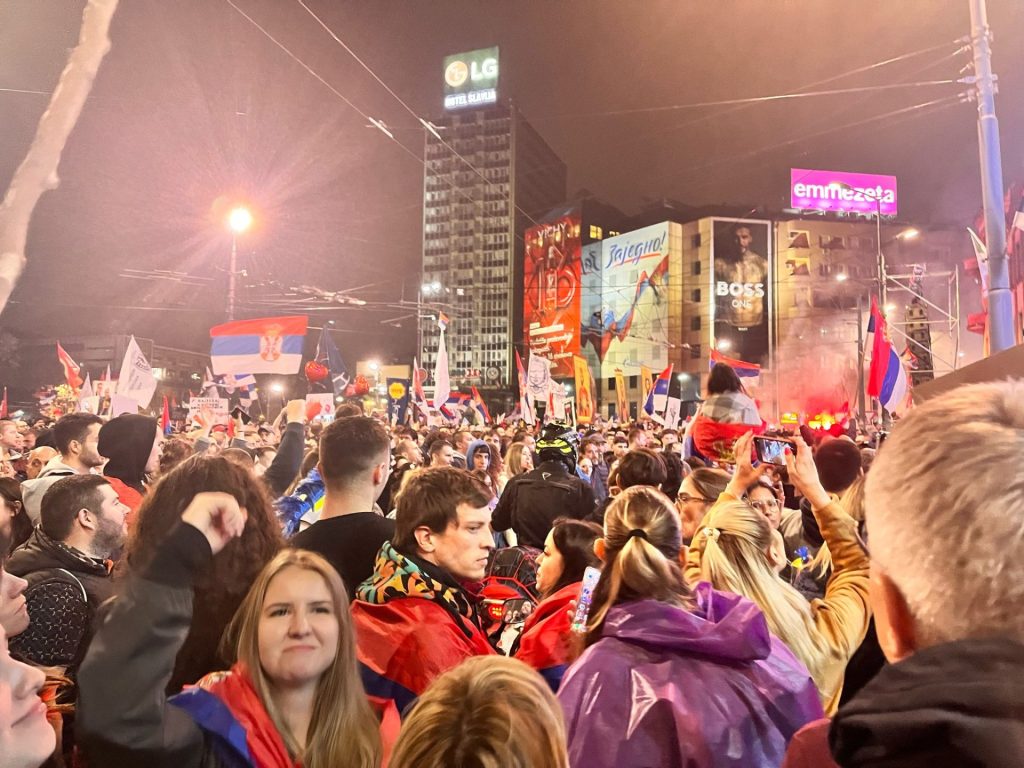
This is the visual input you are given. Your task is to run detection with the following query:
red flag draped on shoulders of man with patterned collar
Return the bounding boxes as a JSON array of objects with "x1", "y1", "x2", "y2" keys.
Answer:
[{"x1": 352, "y1": 597, "x2": 495, "y2": 713}]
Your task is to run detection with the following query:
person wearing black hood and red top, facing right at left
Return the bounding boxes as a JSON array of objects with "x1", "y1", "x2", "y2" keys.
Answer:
[{"x1": 98, "y1": 414, "x2": 160, "y2": 512}]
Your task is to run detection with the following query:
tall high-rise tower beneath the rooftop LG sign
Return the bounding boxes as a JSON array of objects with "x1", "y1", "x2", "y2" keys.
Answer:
[{"x1": 419, "y1": 101, "x2": 566, "y2": 389}]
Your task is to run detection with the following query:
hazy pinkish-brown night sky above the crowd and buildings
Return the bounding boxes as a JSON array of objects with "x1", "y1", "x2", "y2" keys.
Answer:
[{"x1": 0, "y1": 0, "x2": 1024, "y2": 361}]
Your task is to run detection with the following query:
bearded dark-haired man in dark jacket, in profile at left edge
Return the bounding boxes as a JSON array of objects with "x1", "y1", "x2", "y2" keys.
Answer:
[{"x1": 7, "y1": 475, "x2": 128, "y2": 669}]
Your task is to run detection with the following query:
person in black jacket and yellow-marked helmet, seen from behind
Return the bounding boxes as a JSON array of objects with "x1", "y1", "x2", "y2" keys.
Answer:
[{"x1": 493, "y1": 422, "x2": 595, "y2": 549}]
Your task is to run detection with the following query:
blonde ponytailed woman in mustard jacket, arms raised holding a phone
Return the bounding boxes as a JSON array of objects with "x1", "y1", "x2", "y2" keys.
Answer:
[{"x1": 686, "y1": 434, "x2": 871, "y2": 716}]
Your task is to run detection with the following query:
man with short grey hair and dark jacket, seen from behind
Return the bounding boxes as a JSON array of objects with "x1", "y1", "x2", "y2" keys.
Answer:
[{"x1": 784, "y1": 381, "x2": 1024, "y2": 768}]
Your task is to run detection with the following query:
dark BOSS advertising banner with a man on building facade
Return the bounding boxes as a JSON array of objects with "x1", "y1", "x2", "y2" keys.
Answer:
[{"x1": 712, "y1": 219, "x2": 772, "y2": 367}]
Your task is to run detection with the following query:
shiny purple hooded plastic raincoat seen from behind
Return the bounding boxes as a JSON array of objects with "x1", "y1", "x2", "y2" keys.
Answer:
[{"x1": 558, "y1": 584, "x2": 822, "y2": 768}]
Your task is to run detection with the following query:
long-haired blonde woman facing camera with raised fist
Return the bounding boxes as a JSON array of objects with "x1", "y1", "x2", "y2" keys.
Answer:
[{"x1": 77, "y1": 493, "x2": 382, "y2": 768}]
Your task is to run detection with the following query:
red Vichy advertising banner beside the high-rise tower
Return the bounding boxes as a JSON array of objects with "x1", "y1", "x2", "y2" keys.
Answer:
[{"x1": 522, "y1": 213, "x2": 581, "y2": 378}]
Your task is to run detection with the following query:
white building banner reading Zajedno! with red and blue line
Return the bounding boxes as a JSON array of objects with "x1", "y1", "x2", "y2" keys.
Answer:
[{"x1": 581, "y1": 222, "x2": 669, "y2": 377}]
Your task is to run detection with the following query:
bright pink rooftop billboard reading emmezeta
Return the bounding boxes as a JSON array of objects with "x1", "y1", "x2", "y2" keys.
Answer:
[{"x1": 790, "y1": 168, "x2": 896, "y2": 216}]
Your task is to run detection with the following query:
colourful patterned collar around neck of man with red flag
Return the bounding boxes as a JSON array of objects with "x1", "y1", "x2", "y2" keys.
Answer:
[{"x1": 355, "y1": 542, "x2": 478, "y2": 637}]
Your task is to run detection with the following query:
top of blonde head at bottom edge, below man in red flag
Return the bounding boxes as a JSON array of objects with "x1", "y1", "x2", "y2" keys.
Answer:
[{"x1": 388, "y1": 656, "x2": 568, "y2": 768}]
